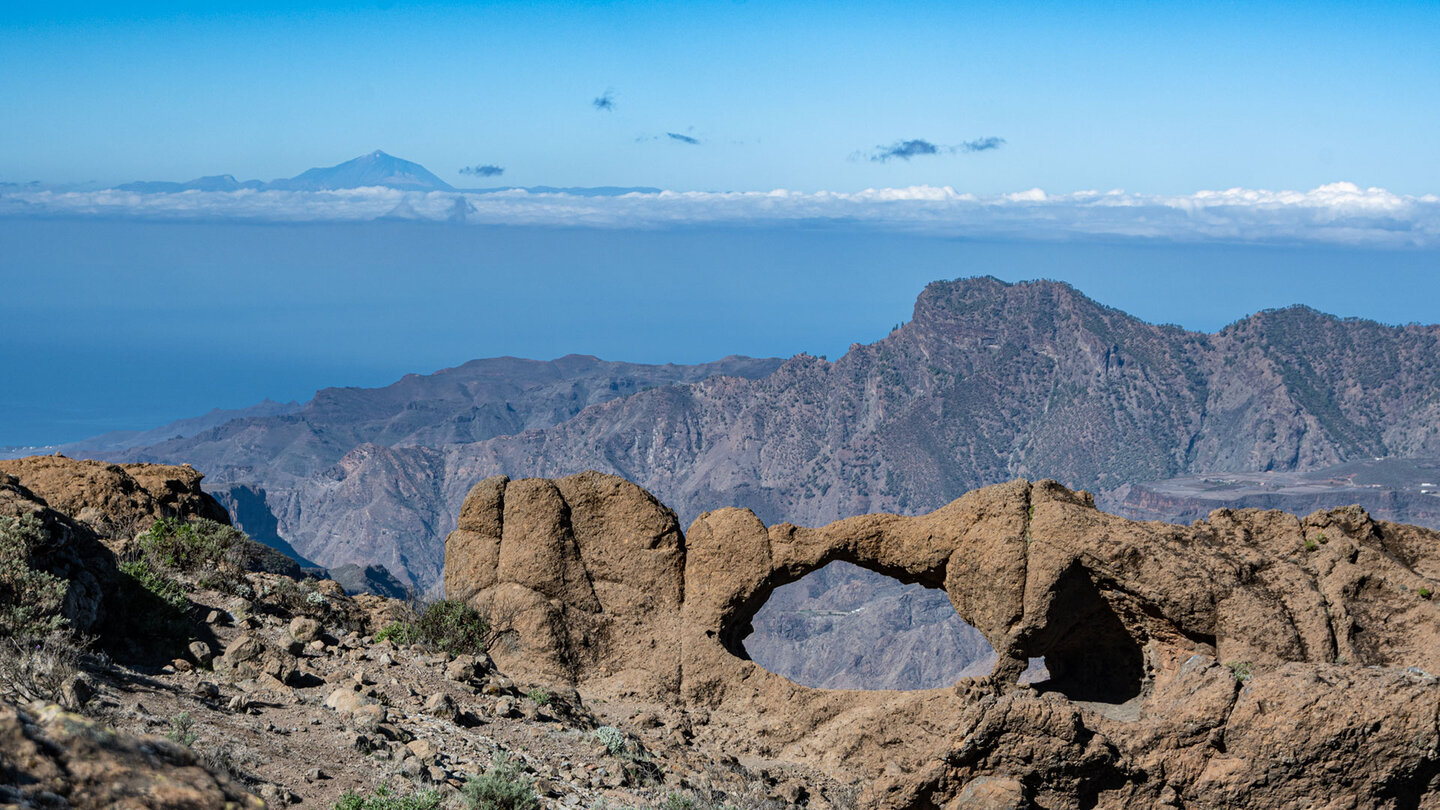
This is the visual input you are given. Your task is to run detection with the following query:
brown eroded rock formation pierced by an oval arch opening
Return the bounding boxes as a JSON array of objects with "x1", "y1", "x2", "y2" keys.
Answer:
[{"x1": 445, "y1": 473, "x2": 1440, "y2": 807}]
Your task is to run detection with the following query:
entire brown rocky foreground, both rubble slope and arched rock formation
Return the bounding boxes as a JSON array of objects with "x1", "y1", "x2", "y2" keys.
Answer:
[{"x1": 8, "y1": 457, "x2": 1440, "y2": 810}]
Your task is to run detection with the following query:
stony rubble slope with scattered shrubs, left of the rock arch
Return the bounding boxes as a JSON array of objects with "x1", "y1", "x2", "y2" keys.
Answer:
[{"x1": 0, "y1": 457, "x2": 835, "y2": 810}]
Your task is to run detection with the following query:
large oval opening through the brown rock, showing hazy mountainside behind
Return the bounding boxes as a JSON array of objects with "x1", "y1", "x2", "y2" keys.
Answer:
[{"x1": 742, "y1": 562, "x2": 1045, "y2": 689}]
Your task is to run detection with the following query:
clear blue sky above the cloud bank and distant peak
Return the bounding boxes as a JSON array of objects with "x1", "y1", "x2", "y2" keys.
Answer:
[{"x1": 0, "y1": 0, "x2": 1440, "y2": 195}]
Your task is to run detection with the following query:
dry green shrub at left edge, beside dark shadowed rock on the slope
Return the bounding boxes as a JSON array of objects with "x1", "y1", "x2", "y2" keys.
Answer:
[{"x1": 0, "y1": 515, "x2": 69, "y2": 638}]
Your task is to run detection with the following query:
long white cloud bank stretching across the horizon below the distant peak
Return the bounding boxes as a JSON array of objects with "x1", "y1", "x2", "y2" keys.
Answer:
[{"x1": 0, "y1": 183, "x2": 1440, "y2": 248}]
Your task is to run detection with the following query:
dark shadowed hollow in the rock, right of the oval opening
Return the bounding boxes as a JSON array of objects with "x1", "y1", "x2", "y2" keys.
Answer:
[{"x1": 1031, "y1": 568, "x2": 1145, "y2": 703}]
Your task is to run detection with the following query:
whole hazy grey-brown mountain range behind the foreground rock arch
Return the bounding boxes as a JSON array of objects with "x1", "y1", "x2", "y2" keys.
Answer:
[{"x1": 87, "y1": 278, "x2": 1440, "y2": 587}]
